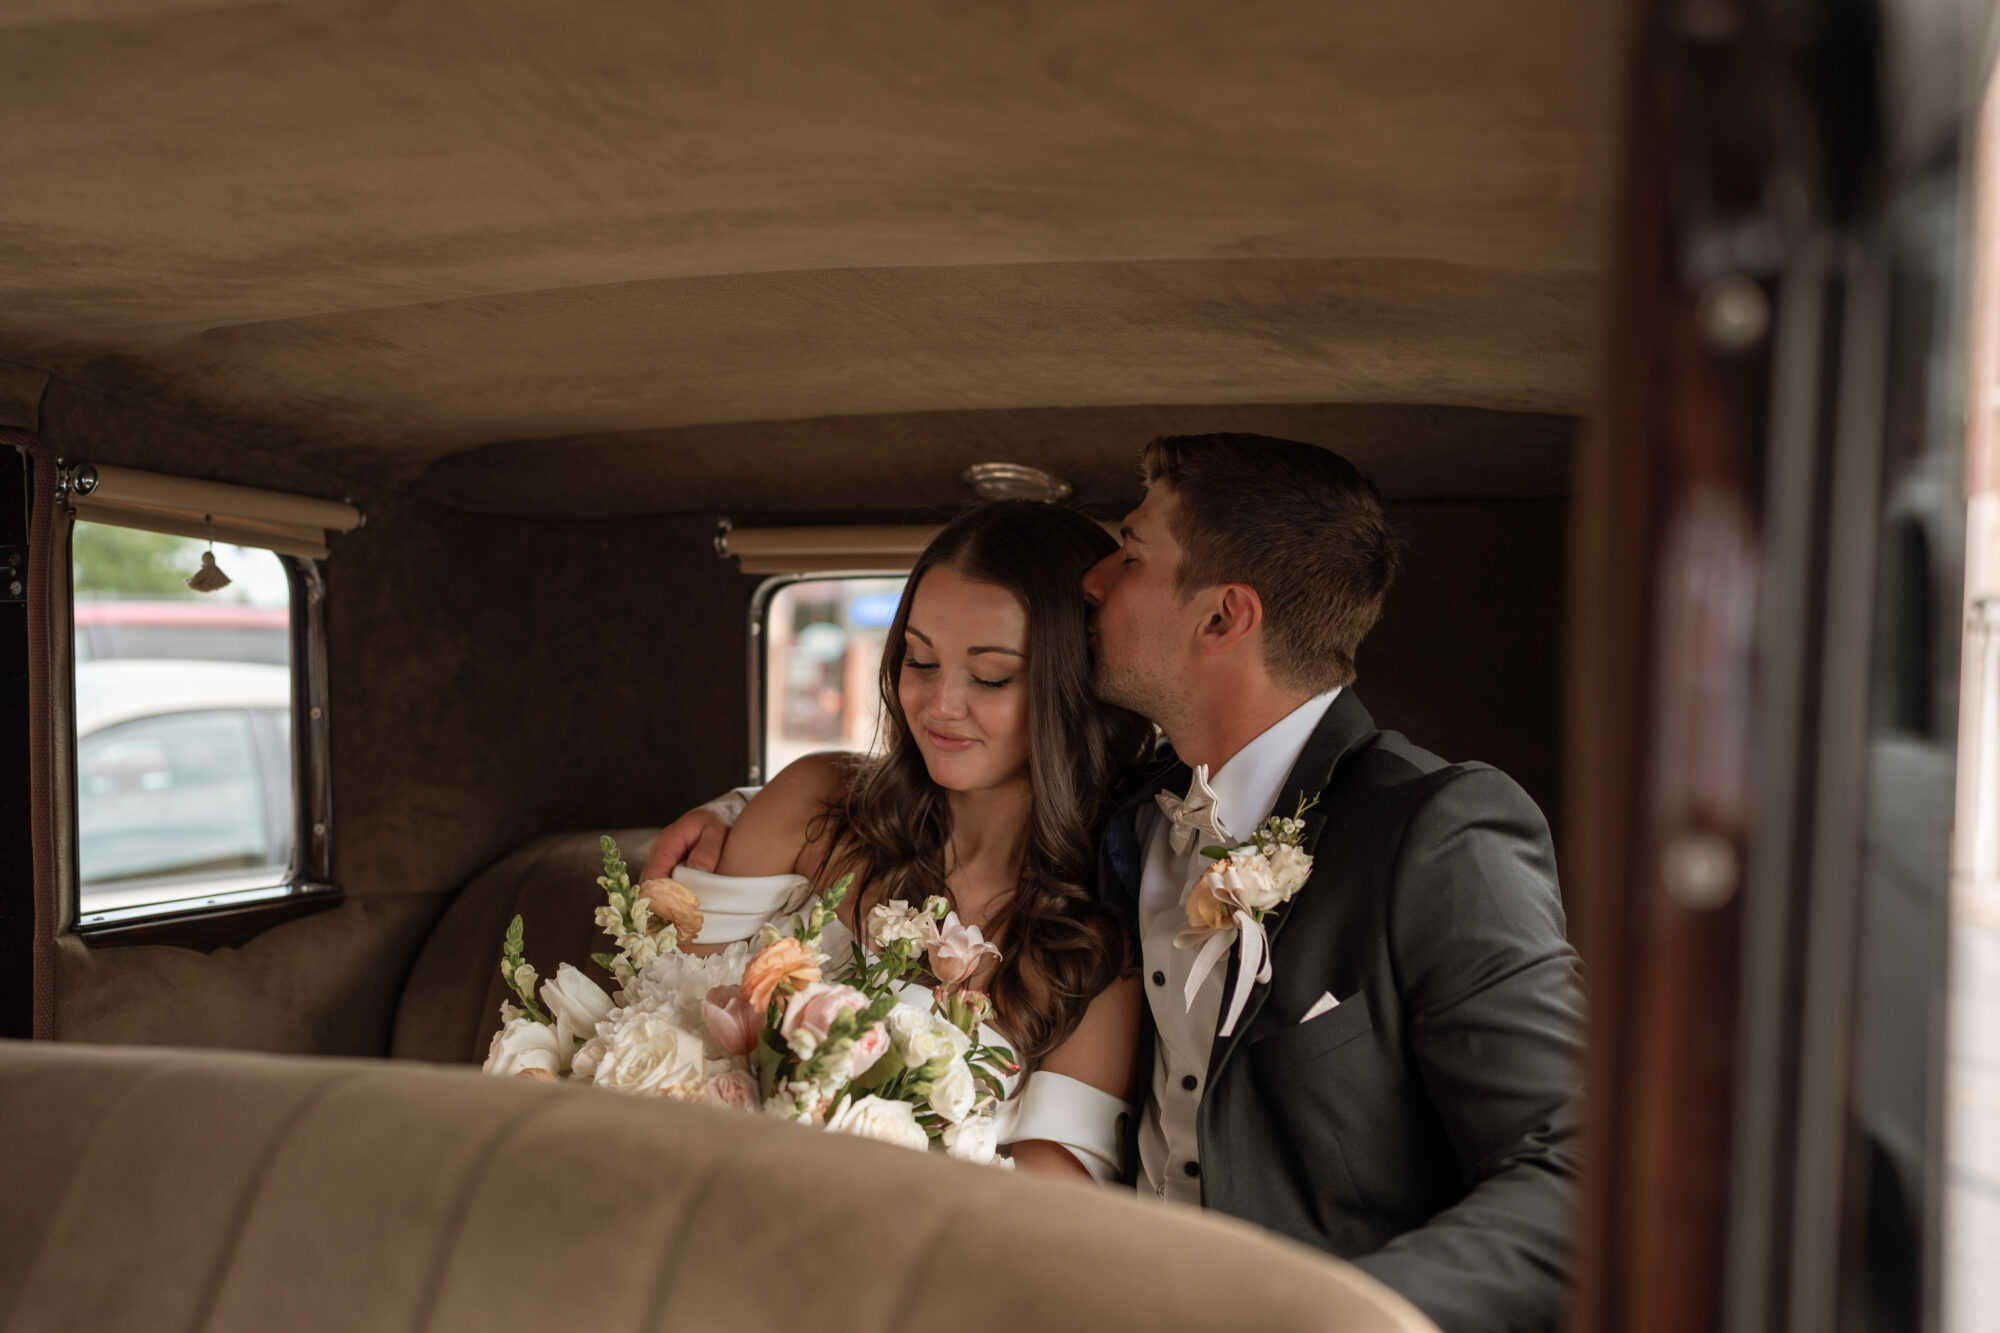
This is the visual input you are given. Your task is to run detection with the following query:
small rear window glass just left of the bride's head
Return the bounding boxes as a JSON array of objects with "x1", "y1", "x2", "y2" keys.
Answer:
[{"x1": 762, "y1": 574, "x2": 904, "y2": 779}]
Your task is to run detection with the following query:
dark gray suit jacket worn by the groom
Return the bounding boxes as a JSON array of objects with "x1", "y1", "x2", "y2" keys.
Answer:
[{"x1": 1098, "y1": 691, "x2": 1584, "y2": 1333}]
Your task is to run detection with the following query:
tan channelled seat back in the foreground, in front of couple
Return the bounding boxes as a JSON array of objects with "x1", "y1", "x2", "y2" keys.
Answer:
[{"x1": 0, "y1": 1043, "x2": 1432, "y2": 1333}]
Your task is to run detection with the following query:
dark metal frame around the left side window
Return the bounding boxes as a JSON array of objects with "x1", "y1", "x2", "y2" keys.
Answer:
[{"x1": 62, "y1": 514, "x2": 346, "y2": 951}]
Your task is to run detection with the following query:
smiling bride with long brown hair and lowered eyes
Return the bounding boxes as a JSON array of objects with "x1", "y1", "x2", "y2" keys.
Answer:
[{"x1": 676, "y1": 500, "x2": 1150, "y2": 1179}]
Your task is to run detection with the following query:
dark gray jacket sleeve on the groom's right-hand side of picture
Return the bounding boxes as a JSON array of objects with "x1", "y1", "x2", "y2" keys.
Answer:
[{"x1": 1356, "y1": 765, "x2": 1584, "y2": 1333}]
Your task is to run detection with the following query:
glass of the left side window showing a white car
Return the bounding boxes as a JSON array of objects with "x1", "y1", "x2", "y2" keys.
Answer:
[{"x1": 70, "y1": 522, "x2": 294, "y2": 913}]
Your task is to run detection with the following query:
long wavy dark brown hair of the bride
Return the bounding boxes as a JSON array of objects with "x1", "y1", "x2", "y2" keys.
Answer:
[{"x1": 814, "y1": 500, "x2": 1152, "y2": 1061}]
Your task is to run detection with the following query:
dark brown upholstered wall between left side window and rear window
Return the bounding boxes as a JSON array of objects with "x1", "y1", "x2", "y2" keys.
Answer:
[{"x1": 37, "y1": 408, "x2": 754, "y2": 1055}]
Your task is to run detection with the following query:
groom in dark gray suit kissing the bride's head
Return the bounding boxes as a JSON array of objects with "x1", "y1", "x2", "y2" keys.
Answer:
[{"x1": 646, "y1": 434, "x2": 1584, "y2": 1333}]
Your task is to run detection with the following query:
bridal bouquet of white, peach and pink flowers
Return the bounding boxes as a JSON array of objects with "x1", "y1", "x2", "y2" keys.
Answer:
[{"x1": 484, "y1": 839, "x2": 1016, "y2": 1165}]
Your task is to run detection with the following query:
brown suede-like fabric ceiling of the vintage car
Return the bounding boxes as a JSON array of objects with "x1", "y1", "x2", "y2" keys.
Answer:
[{"x1": 0, "y1": 0, "x2": 1624, "y2": 514}]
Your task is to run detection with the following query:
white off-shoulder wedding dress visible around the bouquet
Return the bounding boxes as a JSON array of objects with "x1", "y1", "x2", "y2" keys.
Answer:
[{"x1": 672, "y1": 867, "x2": 1132, "y2": 1185}]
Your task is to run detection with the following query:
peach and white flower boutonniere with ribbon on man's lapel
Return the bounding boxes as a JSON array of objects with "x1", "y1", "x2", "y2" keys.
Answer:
[{"x1": 1174, "y1": 797, "x2": 1320, "y2": 1037}]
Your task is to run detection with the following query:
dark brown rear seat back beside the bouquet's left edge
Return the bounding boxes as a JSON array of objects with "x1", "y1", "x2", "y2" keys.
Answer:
[{"x1": 390, "y1": 829, "x2": 656, "y2": 1065}]
